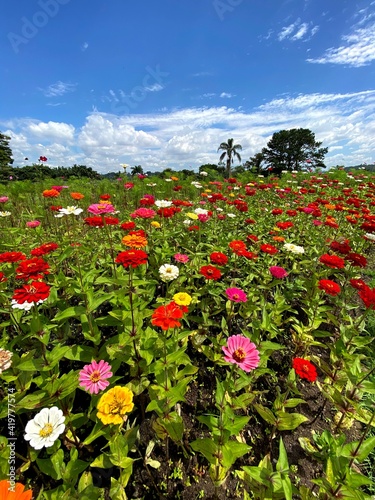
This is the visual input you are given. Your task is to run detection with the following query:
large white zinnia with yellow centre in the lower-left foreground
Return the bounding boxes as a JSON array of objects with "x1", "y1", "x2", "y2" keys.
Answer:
[{"x1": 25, "y1": 406, "x2": 65, "y2": 450}]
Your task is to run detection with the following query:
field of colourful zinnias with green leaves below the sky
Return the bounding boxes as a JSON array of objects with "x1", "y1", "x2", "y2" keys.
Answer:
[{"x1": 0, "y1": 170, "x2": 375, "y2": 500}]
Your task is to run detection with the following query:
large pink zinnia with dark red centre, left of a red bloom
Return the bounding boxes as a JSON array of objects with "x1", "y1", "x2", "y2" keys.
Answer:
[{"x1": 222, "y1": 335, "x2": 260, "y2": 372}]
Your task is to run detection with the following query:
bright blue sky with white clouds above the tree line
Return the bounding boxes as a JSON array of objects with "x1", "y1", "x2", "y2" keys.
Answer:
[{"x1": 0, "y1": 0, "x2": 375, "y2": 173}]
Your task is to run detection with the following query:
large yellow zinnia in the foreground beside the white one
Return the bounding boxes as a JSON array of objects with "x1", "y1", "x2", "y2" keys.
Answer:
[{"x1": 97, "y1": 385, "x2": 134, "y2": 425}]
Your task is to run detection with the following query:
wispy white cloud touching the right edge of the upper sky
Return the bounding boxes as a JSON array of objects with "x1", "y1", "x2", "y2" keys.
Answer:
[{"x1": 307, "y1": 21, "x2": 375, "y2": 68}]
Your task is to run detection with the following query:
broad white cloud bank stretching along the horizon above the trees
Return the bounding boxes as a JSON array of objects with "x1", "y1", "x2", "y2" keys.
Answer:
[{"x1": 4, "y1": 90, "x2": 375, "y2": 172}]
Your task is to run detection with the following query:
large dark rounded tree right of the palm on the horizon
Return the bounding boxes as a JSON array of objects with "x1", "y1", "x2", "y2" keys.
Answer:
[{"x1": 262, "y1": 128, "x2": 328, "y2": 173}]
